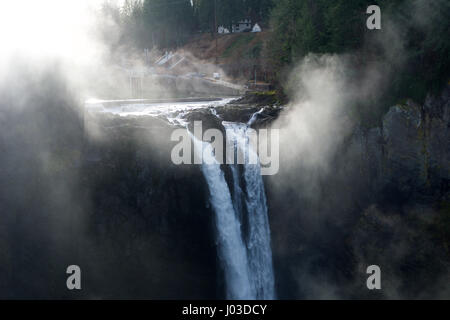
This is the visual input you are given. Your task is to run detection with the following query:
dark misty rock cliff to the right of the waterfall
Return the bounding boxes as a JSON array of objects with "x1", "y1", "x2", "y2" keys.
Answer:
[{"x1": 267, "y1": 88, "x2": 450, "y2": 298}]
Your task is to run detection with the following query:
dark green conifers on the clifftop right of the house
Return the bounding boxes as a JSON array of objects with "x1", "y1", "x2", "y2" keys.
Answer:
[{"x1": 267, "y1": 0, "x2": 450, "y2": 104}]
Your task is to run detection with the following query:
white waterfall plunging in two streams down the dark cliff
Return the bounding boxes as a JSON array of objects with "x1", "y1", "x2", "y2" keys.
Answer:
[{"x1": 191, "y1": 118, "x2": 275, "y2": 300}]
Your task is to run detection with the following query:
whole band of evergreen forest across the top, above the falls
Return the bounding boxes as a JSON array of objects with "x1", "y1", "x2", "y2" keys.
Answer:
[{"x1": 113, "y1": 0, "x2": 450, "y2": 126}]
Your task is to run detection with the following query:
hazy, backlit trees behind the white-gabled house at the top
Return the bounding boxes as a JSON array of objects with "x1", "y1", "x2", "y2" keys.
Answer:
[{"x1": 116, "y1": 0, "x2": 273, "y2": 48}]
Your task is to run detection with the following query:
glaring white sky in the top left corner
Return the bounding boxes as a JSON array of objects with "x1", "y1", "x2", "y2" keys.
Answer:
[{"x1": 0, "y1": 0, "x2": 109, "y2": 62}]
